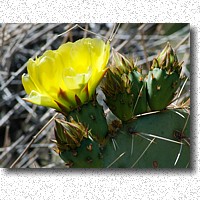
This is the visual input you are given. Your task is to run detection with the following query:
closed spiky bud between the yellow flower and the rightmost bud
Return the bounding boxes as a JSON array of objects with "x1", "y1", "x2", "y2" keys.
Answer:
[{"x1": 102, "y1": 51, "x2": 147, "y2": 121}]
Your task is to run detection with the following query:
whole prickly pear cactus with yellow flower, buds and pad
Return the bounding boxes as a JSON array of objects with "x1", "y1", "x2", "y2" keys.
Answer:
[{"x1": 23, "y1": 36, "x2": 190, "y2": 168}]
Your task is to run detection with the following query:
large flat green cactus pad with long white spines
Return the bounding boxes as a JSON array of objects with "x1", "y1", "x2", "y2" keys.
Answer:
[{"x1": 103, "y1": 110, "x2": 190, "y2": 168}]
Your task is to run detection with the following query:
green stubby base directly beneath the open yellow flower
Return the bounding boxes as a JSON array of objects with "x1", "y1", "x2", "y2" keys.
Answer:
[{"x1": 69, "y1": 101, "x2": 108, "y2": 142}]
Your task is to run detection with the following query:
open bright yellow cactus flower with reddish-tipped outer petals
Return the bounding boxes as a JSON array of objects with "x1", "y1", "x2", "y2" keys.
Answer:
[{"x1": 22, "y1": 38, "x2": 110, "y2": 112}]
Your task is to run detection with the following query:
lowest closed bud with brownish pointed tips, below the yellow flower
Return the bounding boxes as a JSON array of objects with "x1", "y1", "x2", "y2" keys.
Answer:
[{"x1": 54, "y1": 117, "x2": 102, "y2": 168}]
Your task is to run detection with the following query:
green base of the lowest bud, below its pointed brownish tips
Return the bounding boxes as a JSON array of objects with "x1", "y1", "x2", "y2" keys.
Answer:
[{"x1": 59, "y1": 138, "x2": 103, "y2": 168}]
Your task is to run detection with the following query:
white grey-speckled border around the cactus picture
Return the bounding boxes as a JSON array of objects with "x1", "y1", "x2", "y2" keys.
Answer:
[{"x1": 0, "y1": 0, "x2": 200, "y2": 200}]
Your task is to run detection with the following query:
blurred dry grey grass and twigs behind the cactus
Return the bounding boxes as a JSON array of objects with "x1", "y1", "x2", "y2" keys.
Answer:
[{"x1": 0, "y1": 23, "x2": 190, "y2": 168}]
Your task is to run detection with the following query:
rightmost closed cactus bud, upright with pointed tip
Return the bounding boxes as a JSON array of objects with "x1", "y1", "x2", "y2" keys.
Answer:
[{"x1": 147, "y1": 43, "x2": 182, "y2": 110}]
